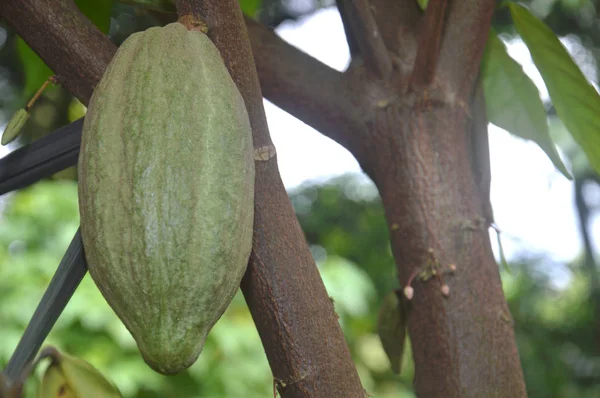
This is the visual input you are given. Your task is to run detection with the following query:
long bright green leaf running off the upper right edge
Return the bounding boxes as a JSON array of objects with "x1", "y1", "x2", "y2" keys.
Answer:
[{"x1": 508, "y1": 3, "x2": 600, "y2": 173}]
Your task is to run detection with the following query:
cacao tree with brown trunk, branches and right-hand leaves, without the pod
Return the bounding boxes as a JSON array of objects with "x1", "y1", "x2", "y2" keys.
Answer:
[{"x1": 0, "y1": 0, "x2": 600, "y2": 397}]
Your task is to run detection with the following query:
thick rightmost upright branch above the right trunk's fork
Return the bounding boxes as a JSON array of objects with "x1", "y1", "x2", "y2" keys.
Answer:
[{"x1": 438, "y1": 0, "x2": 496, "y2": 98}]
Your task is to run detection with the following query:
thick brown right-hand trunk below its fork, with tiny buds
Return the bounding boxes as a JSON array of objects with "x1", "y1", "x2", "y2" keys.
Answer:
[{"x1": 370, "y1": 98, "x2": 525, "y2": 397}]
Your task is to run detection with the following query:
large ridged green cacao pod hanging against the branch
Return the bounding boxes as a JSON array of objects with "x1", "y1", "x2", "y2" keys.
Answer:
[{"x1": 78, "y1": 23, "x2": 254, "y2": 374}]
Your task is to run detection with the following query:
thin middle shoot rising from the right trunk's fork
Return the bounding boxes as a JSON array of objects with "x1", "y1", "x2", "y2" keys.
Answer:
[{"x1": 411, "y1": 0, "x2": 448, "y2": 89}]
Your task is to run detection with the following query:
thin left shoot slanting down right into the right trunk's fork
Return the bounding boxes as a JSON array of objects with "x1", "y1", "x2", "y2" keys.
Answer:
[{"x1": 340, "y1": 0, "x2": 392, "y2": 79}]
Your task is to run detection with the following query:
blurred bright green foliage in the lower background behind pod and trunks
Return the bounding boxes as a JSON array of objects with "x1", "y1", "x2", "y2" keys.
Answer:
[{"x1": 0, "y1": 176, "x2": 600, "y2": 398}]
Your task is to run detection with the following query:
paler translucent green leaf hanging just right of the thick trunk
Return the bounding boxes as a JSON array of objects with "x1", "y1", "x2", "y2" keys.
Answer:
[{"x1": 483, "y1": 30, "x2": 571, "y2": 179}]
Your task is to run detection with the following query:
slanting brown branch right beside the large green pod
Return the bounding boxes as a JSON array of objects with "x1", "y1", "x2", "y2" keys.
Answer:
[{"x1": 171, "y1": 0, "x2": 364, "y2": 397}]
